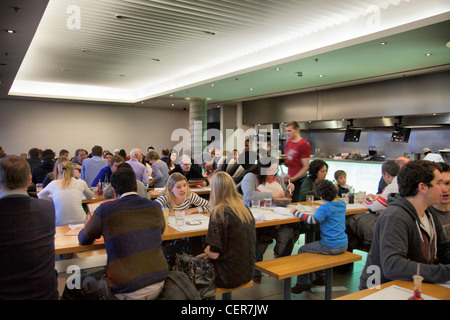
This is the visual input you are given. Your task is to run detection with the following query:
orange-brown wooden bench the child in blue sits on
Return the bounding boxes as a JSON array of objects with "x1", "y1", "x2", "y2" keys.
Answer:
[{"x1": 255, "y1": 251, "x2": 362, "y2": 300}]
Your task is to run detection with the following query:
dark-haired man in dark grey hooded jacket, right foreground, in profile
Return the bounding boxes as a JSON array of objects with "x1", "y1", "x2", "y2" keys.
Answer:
[{"x1": 359, "y1": 160, "x2": 450, "y2": 290}]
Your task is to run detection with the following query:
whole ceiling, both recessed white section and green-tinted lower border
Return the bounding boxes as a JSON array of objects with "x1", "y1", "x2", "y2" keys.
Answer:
[{"x1": 0, "y1": 0, "x2": 450, "y2": 106}]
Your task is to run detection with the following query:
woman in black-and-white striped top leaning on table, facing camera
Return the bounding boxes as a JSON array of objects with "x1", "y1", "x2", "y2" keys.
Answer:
[{"x1": 155, "y1": 172, "x2": 209, "y2": 215}]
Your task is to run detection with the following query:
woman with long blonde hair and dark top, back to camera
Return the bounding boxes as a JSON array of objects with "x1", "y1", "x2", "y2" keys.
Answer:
[{"x1": 198, "y1": 171, "x2": 256, "y2": 288}]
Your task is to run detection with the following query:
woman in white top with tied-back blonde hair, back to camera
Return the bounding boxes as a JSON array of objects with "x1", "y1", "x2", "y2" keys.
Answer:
[{"x1": 37, "y1": 159, "x2": 93, "y2": 226}]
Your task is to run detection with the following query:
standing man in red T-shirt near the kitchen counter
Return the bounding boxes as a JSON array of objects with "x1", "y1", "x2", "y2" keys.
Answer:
[{"x1": 284, "y1": 121, "x2": 311, "y2": 202}]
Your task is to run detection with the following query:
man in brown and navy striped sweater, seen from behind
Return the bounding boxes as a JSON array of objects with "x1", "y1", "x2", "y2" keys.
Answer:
[{"x1": 68, "y1": 167, "x2": 168, "y2": 300}]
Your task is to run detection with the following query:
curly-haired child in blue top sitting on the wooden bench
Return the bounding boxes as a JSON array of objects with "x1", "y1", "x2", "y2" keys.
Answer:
[{"x1": 291, "y1": 180, "x2": 348, "y2": 294}]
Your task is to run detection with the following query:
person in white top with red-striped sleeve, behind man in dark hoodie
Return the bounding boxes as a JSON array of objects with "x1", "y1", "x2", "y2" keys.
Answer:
[{"x1": 364, "y1": 160, "x2": 400, "y2": 212}]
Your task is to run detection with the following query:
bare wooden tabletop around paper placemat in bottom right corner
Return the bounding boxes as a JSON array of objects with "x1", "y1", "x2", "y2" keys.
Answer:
[{"x1": 335, "y1": 280, "x2": 450, "y2": 300}]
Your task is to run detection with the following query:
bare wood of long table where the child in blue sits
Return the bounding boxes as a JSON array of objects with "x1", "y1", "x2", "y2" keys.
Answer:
[{"x1": 55, "y1": 199, "x2": 367, "y2": 254}]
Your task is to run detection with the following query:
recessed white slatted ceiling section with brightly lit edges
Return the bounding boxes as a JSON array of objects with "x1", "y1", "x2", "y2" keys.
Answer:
[{"x1": 0, "y1": 0, "x2": 450, "y2": 107}]
